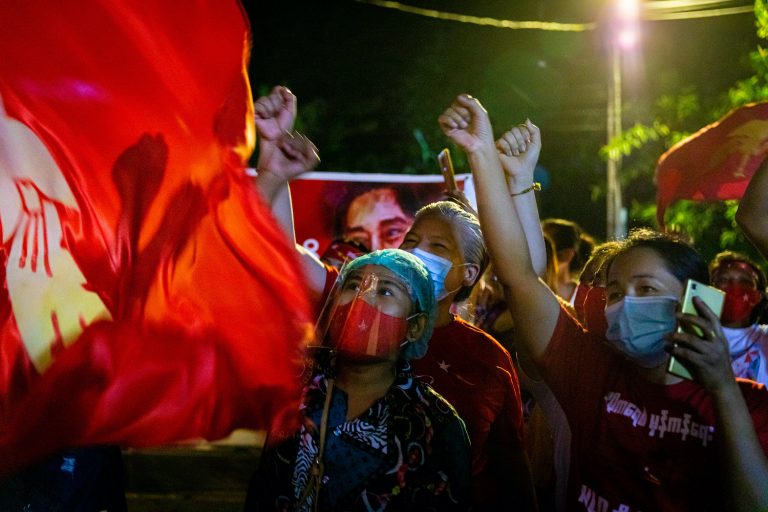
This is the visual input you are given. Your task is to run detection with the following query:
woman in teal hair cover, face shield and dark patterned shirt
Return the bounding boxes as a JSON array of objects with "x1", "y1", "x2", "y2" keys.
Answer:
[{"x1": 246, "y1": 249, "x2": 470, "y2": 511}]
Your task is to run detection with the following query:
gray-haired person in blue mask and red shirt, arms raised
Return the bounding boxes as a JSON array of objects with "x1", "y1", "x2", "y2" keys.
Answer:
[{"x1": 249, "y1": 88, "x2": 546, "y2": 511}]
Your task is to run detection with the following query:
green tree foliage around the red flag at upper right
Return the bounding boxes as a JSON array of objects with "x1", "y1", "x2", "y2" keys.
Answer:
[{"x1": 600, "y1": 0, "x2": 768, "y2": 261}]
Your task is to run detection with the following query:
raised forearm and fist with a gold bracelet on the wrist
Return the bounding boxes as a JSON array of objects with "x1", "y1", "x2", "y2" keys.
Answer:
[{"x1": 496, "y1": 119, "x2": 547, "y2": 277}]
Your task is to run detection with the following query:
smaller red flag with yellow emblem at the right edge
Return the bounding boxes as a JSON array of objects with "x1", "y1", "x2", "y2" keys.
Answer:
[{"x1": 654, "y1": 103, "x2": 768, "y2": 228}]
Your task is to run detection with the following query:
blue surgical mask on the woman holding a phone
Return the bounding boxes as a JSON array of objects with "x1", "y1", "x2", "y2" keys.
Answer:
[{"x1": 605, "y1": 296, "x2": 678, "y2": 368}]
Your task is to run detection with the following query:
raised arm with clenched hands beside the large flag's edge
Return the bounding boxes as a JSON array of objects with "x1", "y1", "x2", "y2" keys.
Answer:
[{"x1": 253, "y1": 86, "x2": 326, "y2": 294}]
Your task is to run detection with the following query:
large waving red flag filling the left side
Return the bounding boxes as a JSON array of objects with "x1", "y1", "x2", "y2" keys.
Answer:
[{"x1": 0, "y1": 0, "x2": 309, "y2": 473}]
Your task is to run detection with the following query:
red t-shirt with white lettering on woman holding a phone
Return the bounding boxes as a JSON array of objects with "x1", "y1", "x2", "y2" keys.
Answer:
[{"x1": 540, "y1": 310, "x2": 768, "y2": 512}]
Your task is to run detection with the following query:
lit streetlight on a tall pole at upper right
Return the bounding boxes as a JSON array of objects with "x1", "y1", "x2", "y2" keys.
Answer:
[{"x1": 606, "y1": 0, "x2": 640, "y2": 238}]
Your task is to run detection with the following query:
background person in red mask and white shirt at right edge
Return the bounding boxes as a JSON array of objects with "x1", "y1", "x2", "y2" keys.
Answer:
[{"x1": 709, "y1": 251, "x2": 768, "y2": 384}]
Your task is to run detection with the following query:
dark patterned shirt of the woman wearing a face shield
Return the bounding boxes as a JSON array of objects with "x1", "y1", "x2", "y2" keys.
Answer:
[{"x1": 246, "y1": 363, "x2": 470, "y2": 511}]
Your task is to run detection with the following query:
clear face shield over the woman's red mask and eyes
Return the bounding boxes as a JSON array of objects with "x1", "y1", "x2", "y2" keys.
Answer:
[{"x1": 316, "y1": 265, "x2": 412, "y2": 363}]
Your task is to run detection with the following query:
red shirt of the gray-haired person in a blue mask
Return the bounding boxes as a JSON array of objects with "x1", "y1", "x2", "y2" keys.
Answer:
[{"x1": 411, "y1": 317, "x2": 523, "y2": 510}]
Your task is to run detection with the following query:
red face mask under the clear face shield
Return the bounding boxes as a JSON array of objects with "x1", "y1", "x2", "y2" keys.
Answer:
[{"x1": 329, "y1": 299, "x2": 408, "y2": 361}]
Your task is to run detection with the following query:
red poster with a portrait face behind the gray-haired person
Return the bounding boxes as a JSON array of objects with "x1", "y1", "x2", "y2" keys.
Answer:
[{"x1": 280, "y1": 172, "x2": 476, "y2": 256}]
